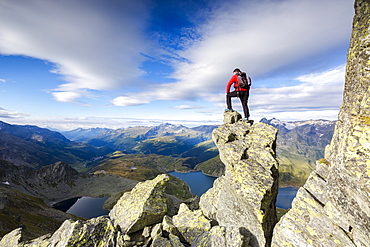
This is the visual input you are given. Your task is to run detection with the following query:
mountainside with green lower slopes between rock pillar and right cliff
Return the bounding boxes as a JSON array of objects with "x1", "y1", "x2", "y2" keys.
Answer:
[{"x1": 261, "y1": 118, "x2": 336, "y2": 186}]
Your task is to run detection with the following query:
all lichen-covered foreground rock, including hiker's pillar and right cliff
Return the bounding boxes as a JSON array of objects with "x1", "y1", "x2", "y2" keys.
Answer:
[{"x1": 0, "y1": 0, "x2": 370, "y2": 247}]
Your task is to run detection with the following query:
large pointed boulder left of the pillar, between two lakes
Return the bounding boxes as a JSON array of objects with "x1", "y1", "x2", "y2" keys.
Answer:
[{"x1": 109, "y1": 174, "x2": 170, "y2": 233}]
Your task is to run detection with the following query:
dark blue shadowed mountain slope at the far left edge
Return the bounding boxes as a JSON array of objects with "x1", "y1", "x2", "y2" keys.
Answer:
[{"x1": 0, "y1": 121, "x2": 112, "y2": 168}]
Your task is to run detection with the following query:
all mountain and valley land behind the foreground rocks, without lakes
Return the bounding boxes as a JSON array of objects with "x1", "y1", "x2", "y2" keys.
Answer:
[{"x1": 0, "y1": 119, "x2": 334, "y2": 238}]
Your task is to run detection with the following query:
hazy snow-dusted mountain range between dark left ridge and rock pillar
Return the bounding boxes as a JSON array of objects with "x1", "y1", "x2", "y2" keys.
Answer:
[{"x1": 62, "y1": 123, "x2": 218, "y2": 166}]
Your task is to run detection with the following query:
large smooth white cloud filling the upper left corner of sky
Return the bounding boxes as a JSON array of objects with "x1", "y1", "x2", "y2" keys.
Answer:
[{"x1": 0, "y1": 0, "x2": 148, "y2": 92}]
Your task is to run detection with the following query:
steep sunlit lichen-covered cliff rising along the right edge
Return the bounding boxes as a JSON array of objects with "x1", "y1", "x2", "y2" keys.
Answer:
[{"x1": 272, "y1": 0, "x2": 370, "y2": 246}]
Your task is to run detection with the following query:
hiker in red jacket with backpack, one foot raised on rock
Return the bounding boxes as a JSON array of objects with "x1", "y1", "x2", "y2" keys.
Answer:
[{"x1": 225, "y1": 68, "x2": 249, "y2": 121}]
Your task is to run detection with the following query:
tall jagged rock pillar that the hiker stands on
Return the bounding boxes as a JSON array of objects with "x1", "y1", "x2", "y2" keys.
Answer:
[{"x1": 200, "y1": 112, "x2": 278, "y2": 246}]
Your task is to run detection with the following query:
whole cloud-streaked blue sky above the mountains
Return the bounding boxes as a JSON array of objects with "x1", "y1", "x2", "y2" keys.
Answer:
[{"x1": 0, "y1": 0, "x2": 354, "y2": 130}]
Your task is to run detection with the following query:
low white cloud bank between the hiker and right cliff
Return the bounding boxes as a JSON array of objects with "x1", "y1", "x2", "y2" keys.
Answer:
[{"x1": 250, "y1": 65, "x2": 345, "y2": 119}]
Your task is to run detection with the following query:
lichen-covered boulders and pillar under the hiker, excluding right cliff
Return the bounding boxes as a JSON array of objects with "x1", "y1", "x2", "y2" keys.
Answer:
[{"x1": 0, "y1": 112, "x2": 278, "y2": 247}]
